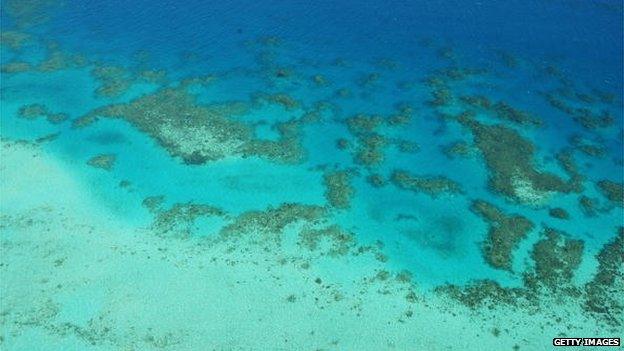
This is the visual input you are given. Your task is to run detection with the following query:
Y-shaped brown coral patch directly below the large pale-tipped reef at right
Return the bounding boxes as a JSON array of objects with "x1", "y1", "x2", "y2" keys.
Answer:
[{"x1": 471, "y1": 200, "x2": 533, "y2": 271}]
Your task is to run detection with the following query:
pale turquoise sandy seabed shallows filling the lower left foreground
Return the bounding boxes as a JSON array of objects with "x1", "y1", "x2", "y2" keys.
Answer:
[{"x1": 0, "y1": 142, "x2": 597, "y2": 350}]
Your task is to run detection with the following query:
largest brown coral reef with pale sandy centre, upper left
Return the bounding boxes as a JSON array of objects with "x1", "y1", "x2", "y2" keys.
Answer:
[{"x1": 74, "y1": 88, "x2": 305, "y2": 164}]
